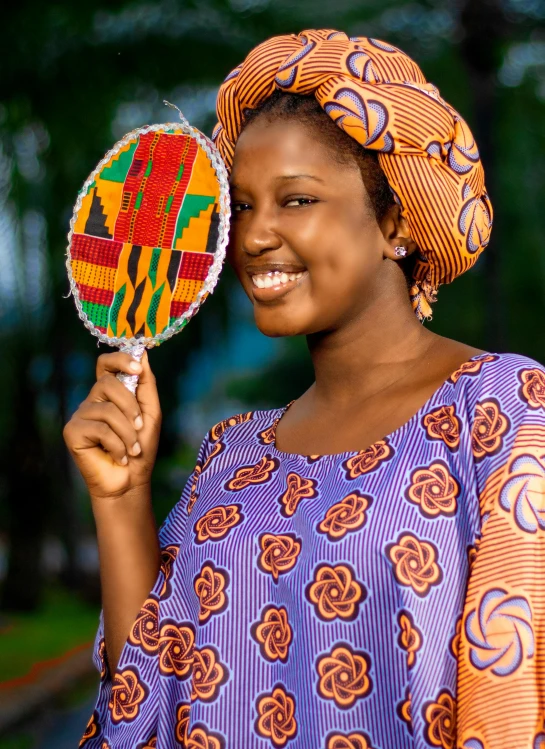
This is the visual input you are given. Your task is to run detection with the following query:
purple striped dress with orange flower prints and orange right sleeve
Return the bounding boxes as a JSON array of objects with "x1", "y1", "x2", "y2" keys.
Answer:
[{"x1": 81, "y1": 354, "x2": 545, "y2": 749}]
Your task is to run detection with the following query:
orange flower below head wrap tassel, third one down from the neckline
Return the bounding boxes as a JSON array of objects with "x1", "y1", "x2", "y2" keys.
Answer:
[{"x1": 386, "y1": 533, "x2": 443, "y2": 597}]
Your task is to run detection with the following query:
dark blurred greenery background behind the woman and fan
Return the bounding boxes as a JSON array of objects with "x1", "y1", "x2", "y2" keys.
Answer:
[{"x1": 0, "y1": 0, "x2": 545, "y2": 749}]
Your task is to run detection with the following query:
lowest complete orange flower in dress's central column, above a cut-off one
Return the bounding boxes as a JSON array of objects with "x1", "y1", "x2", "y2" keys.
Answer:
[{"x1": 316, "y1": 643, "x2": 371, "y2": 708}]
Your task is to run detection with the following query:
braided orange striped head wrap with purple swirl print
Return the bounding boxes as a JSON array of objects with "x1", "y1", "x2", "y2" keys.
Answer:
[{"x1": 213, "y1": 29, "x2": 492, "y2": 319}]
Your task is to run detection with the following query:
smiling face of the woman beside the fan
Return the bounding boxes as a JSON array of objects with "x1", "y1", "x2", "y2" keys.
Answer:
[{"x1": 229, "y1": 118, "x2": 387, "y2": 336}]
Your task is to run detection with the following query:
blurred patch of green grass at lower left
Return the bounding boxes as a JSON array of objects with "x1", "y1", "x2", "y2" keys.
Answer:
[{"x1": 0, "y1": 589, "x2": 99, "y2": 683}]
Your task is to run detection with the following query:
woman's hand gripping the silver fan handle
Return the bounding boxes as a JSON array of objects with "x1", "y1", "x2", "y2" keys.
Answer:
[{"x1": 64, "y1": 352, "x2": 161, "y2": 498}]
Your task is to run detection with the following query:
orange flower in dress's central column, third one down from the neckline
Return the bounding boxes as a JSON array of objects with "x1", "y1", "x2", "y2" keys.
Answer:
[{"x1": 306, "y1": 564, "x2": 367, "y2": 621}]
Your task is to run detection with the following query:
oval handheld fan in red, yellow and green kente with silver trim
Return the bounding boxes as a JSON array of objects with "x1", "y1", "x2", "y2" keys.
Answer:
[{"x1": 66, "y1": 108, "x2": 230, "y2": 392}]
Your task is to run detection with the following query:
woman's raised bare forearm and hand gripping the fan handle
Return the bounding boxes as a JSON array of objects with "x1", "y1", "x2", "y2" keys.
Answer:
[{"x1": 64, "y1": 353, "x2": 161, "y2": 672}]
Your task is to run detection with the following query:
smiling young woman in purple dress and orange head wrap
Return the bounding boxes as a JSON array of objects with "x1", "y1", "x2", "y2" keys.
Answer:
[{"x1": 66, "y1": 31, "x2": 545, "y2": 749}]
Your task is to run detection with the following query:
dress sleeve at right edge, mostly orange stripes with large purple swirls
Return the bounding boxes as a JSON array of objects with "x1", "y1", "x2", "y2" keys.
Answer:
[{"x1": 457, "y1": 357, "x2": 545, "y2": 749}]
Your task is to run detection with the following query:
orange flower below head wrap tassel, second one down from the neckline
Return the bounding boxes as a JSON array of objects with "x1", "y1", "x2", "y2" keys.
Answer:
[{"x1": 405, "y1": 460, "x2": 460, "y2": 518}]
